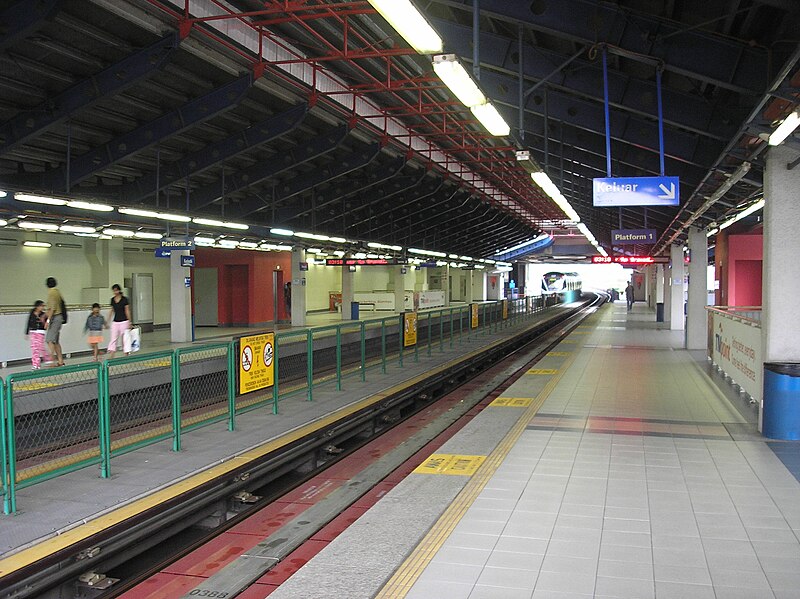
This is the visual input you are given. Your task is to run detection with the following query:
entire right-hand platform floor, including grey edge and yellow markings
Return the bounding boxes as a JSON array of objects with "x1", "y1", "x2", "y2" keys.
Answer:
[{"x1": 270, "y1": 303, "x2": 800, "y2": 599}]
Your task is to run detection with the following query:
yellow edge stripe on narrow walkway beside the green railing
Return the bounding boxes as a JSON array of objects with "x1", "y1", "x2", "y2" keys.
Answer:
[{"x1": 0, "y1": 312, "x2": 560, "y2": 578}]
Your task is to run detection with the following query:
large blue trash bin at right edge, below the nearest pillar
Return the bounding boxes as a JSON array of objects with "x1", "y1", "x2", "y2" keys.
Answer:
[{"x1": 761, "y1": 362, "x2": 800, "y2": 441}]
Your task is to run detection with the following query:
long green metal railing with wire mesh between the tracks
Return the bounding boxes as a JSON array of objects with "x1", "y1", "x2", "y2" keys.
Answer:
[{"x1": 0, "y1": 297, "x2": 558, "y2": 513}]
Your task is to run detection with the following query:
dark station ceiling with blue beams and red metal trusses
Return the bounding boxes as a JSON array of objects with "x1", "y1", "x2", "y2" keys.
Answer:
[{"x1": 0, "y1": 0, "x2": 800, "y2": 257}]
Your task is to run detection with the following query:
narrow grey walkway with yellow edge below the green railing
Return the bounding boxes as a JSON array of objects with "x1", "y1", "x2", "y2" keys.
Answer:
[{"x1": 0, "y1": 304, "x2": 564, "y2": 578}]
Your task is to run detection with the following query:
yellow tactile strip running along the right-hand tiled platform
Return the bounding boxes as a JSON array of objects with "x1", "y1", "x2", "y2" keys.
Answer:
[{"x1": 375, "y1": 317, "x2": 591, "y2": 599}]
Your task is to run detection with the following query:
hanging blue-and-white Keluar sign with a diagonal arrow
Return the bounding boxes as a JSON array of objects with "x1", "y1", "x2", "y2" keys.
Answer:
[{"x1": 592, "y1": 177, "x2": 680, "y2": 208}]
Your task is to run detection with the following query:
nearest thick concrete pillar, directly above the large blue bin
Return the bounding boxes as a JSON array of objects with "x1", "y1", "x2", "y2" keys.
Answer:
[{"x1": 761, "y1": 146, "x2": 800, "y2": 362}]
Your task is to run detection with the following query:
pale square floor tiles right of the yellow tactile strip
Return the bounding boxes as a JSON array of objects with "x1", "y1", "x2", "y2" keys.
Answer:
[{"x1": 277, "y1": 304, "x2": 800, "y2": 599}]
